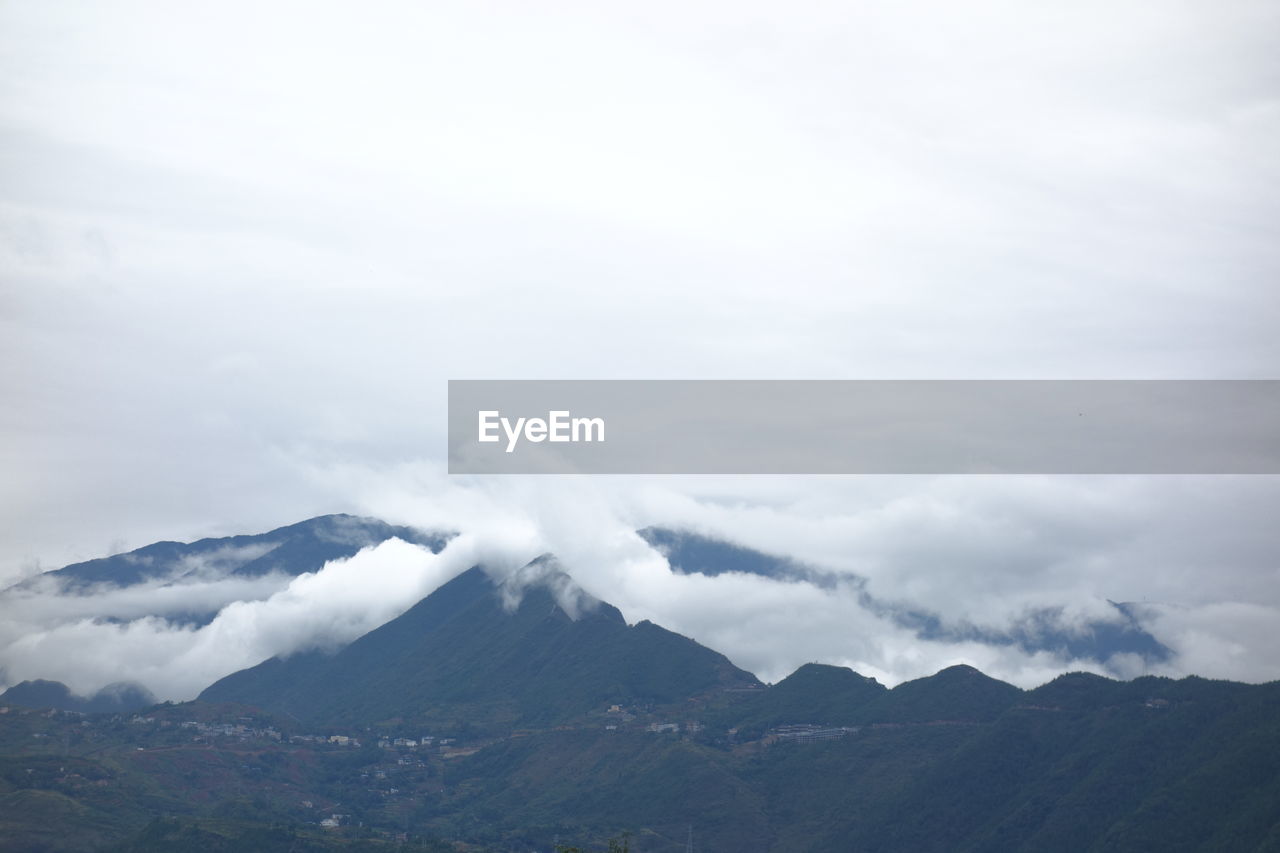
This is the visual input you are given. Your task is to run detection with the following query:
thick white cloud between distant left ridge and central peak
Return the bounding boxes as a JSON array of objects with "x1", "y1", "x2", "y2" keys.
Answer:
[{"x1": 0, "y1": 539, "x2": 472, "y2": 699}]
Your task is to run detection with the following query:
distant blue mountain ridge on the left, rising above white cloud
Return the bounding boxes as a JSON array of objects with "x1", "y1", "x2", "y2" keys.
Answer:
[{"x1": 20, "y1": 515, "x2": 453, "y2": 592}]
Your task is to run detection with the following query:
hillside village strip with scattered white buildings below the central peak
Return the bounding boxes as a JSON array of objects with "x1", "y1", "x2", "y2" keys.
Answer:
[{"x1": 0, "y1": 704, "x2": 858, "y2": 829}]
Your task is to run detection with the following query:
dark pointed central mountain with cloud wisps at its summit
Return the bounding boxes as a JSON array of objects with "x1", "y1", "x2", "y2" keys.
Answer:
[{"x1": 200, "y1": 557, "x2": 759, "y2": 731}]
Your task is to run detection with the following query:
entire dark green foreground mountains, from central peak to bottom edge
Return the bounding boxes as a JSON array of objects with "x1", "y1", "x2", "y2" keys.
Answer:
[{"x1": 0, "y1": 565, "x2": 1280, "y2": 853}]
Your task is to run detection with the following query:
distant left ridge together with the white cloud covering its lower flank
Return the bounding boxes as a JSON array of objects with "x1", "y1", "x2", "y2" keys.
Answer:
[{"x1": 0, "y1": 515, "x2": 461, "y2": 699}]
